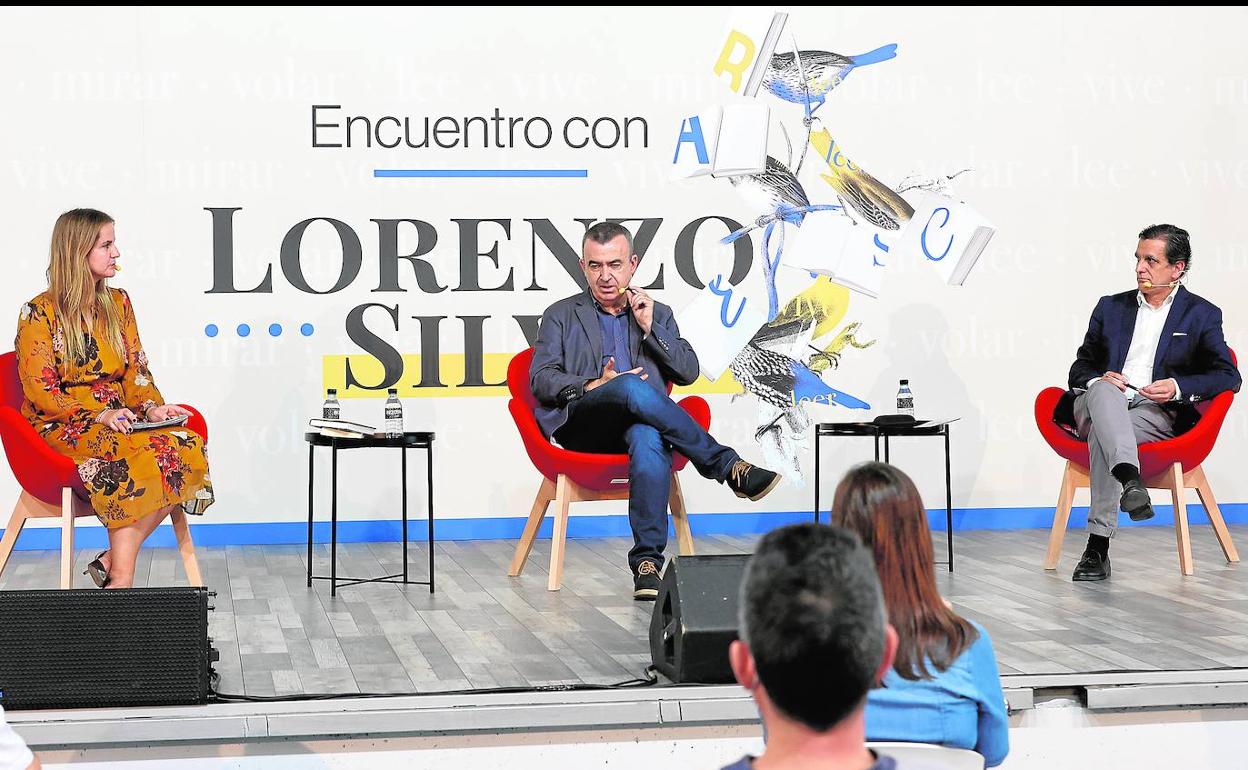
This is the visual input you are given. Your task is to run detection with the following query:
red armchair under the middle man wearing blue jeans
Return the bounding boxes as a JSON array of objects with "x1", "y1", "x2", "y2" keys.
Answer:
[{"x1": 507, "y1": 348, "x2": 710, "y2": 590}]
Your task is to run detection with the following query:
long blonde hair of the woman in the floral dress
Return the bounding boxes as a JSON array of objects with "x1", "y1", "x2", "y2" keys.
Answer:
[{"x1": 47, "y1": 208, "x2": 126, "y2": 364}]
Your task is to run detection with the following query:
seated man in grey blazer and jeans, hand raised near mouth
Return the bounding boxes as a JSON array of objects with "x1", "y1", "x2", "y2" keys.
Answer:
[{"x1": 529, "y1": 222, "x2": 780, "y2": 600}]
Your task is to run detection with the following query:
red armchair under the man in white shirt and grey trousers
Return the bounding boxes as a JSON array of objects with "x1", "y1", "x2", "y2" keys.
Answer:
[{"x1": 1036, "y1": 351, "x2": 1239, "y2": 575}]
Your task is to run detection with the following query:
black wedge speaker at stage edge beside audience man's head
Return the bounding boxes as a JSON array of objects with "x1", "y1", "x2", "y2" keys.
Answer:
[{"x1": 650, "y1": 554, "x2": 750, "y2": 684}]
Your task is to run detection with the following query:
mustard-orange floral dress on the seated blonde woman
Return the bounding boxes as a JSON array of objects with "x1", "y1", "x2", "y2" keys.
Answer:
[{"x1": 16, "y1": 288, "x2": 213, "y2": 528}]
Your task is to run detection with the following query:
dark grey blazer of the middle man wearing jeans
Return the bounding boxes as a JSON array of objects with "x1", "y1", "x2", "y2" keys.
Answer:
[{"x1": 529, "y1": 290, "x2": 699, "y2": 437}]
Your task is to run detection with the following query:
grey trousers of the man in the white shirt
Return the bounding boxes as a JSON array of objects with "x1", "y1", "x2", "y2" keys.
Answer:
[{"x1": 1075, "y1": 379, "x2": 1174, "y2": 538}]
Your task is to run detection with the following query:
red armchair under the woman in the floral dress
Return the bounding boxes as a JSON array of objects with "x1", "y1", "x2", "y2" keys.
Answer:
[{"x1": 0, "y1": 352, "x2": 208, "y2": 588}]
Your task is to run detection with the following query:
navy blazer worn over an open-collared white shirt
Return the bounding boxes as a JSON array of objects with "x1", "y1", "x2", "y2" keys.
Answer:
[{"x1": 1053, "y1": 286, "x2": 1242, "y2": 434}]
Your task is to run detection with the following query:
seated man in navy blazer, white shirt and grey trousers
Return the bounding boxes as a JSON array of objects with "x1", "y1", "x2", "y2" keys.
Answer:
[{"x1": 1053, "y1": 225, "x2": 1241, "y2": 580}]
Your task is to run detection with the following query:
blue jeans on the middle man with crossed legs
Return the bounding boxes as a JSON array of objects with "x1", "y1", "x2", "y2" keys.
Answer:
[{"x1": 554, "y1": 374, "x2": 740, "y2": 572}]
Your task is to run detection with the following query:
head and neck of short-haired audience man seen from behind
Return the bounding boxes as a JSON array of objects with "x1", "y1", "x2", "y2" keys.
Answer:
[{"x1": 724, "y1": 524, "x2": 897, "y2": 770}]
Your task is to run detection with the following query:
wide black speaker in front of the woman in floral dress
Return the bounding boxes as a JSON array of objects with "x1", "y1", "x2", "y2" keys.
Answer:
[{"x1": 0, "y1": 588, "x2": 215, "y2": 709}]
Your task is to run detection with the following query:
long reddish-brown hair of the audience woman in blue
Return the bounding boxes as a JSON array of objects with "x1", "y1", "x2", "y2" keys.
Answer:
[{"x1": 831, "y1": 463, "x2": 977, "y2": 680}]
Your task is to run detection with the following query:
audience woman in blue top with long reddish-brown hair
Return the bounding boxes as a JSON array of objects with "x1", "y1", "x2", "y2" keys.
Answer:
[{"x1": 831, "y1": 463, "x2": 1010, "y2": 768}]
